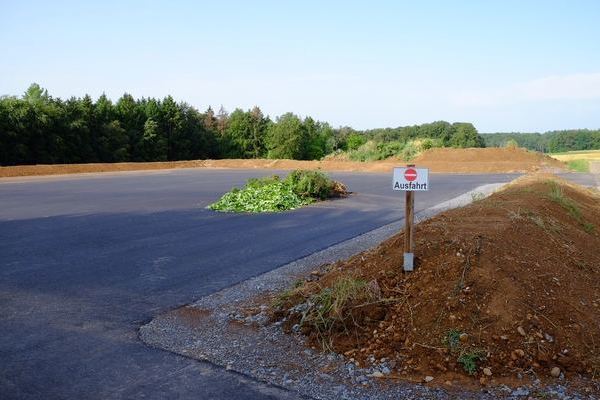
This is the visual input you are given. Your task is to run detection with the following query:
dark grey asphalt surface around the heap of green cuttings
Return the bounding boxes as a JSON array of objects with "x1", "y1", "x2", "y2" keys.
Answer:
[{"x1": 0, "y1": 170, "x2": 592, "y2": 399}]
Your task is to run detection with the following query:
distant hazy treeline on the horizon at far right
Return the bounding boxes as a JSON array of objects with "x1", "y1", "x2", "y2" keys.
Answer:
[{"x1": 481, "y1": 129, "x2": 600, "y2": 153}]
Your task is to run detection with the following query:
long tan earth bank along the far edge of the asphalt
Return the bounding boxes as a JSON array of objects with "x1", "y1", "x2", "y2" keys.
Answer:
[{"x1": 0, "y1": 148, "x2": 564, "y2": 177}]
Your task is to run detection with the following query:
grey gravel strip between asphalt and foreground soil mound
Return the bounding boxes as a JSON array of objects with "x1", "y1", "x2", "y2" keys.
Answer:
[{"x1": 140, "y1": 184, "x2": 598, "y2": 399}]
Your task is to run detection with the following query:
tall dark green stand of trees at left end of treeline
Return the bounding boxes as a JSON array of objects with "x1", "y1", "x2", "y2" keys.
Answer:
[{"x1": 0, "y1": 84, "x2": 218, "y2": 165}]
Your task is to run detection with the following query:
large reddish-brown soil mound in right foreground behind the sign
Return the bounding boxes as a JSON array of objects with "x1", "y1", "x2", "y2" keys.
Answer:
[{"x1": 273, "y1": 175, "x2": 600, "y2": 384}]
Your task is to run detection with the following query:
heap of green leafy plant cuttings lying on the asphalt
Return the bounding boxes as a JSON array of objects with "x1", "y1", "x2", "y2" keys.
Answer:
[{"x1": 208, "y1": 170, "x2": 341, "y2": 212}]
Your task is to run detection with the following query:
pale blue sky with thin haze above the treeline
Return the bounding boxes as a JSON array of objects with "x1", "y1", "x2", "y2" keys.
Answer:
[{"x1": 0, "y1": 0, "x2": 600, "y2": 132}]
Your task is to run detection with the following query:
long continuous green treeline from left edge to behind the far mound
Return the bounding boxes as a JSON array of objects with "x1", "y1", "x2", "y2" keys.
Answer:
[{"x1": 0, "y1": 84, "x2": 483, "y2": 165}]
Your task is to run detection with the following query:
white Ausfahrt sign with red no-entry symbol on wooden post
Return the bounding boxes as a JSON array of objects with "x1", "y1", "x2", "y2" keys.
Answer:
[{"x1": 393, "y1": 164, "x2": 429, "y2": 271}]
